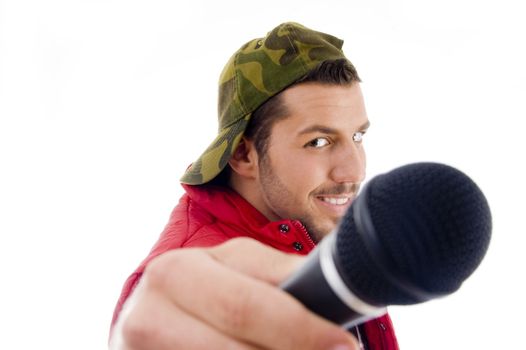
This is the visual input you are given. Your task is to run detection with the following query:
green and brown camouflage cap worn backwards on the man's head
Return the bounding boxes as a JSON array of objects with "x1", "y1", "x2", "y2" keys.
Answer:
[{"x1": 181, "y1": 22, "x2": 345, "y2": 185}]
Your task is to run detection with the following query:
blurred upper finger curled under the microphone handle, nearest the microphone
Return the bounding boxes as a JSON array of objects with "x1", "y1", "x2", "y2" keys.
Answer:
[{"x1": 146, "y1": 249, "x2": 357, "y2": 350}]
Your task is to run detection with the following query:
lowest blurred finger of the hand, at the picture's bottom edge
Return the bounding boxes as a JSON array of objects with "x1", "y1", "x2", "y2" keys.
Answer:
[{"x1": 112, "y1": 284, "x2": 260, "y2": 350}]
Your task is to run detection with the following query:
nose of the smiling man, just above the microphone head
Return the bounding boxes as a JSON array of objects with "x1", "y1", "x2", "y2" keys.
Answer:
[{"x1": 330, "y1": 144, "x2": 366, "y2": 183}]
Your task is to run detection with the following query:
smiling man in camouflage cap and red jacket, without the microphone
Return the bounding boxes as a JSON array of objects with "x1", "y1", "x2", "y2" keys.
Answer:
[{"x1": 111, "y1": 23, "x2": 398, "y2": 349}]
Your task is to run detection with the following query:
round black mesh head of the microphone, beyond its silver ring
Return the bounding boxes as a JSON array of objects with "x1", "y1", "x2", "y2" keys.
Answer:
[{"x1": 336, "y1": 163, "x2": 491, "y2": 305}]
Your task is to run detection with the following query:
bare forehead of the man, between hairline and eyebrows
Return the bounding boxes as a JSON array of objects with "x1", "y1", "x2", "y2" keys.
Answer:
[{"x1": 275, "y1": 83, "x2": 368, "y2": 136}]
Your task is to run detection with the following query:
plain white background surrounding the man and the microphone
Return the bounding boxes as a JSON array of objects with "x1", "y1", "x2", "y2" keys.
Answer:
[{"x1": 0, "y1": 0, "x2": 526, "y2": 350}]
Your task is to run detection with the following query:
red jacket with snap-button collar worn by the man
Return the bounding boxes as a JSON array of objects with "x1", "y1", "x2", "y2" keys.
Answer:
[{"x1": 112, "y1": 185, "x2": 398, "y2": 350}]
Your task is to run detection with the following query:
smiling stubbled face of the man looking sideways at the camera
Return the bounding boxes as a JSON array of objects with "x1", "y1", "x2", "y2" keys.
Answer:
[{"x1": 257, "y1": 83, "x2": 369, "y2": 240}]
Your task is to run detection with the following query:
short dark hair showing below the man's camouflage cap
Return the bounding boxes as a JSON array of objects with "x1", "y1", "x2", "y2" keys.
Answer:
[{"x1": 210, "y1": 58, "x2": 361, "y2": 185}]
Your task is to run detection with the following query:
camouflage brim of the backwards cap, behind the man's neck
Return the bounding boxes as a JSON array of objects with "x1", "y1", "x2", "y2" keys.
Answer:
[{"x1": 180, "y1": 114, "x2": 251, "y2": 185}]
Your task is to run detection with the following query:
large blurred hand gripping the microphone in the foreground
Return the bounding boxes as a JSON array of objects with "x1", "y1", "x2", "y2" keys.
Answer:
[{"x1": 110, "y1": 238, "x2": 358, "y2": 350}]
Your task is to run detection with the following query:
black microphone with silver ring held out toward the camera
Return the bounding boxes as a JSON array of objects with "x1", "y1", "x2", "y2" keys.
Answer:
[{"x1": 281, "y1": 163, "x2": 492, "y2": 328}]
